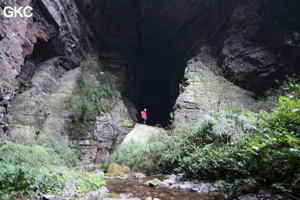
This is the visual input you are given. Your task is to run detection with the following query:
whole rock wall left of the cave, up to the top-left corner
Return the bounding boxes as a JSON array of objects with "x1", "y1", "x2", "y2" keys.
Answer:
[{"x1": 0, "y1": 0, "x2": 134, "y2": 163}]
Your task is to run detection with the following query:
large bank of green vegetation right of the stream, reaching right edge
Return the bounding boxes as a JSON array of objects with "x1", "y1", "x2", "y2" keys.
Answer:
[{"x1": 108, "y1": 84, "x2": 300, "y2": 198}]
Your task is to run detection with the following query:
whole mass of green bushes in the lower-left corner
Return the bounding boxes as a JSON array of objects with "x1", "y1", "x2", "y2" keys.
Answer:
[{"x1": 0, "y1": 134, "x2": 105, "y2": 199}]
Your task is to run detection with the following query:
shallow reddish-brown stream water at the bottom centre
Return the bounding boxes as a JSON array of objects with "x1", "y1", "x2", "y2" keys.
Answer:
[{"x1": 106, "y1": 177, "x2": 214, "y2": 200}]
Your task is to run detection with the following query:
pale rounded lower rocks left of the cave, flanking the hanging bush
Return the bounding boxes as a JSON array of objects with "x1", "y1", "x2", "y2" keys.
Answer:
[{"x1": 6, "y1": 56, "x2": 133, "y2": 164}]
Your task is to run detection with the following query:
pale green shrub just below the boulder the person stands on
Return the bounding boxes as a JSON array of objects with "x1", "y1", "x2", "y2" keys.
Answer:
[{"x1": 105, "y1": 134, "x2": 173, "y2": 171}]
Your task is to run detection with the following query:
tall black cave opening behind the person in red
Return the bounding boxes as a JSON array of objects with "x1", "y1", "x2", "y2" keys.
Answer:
[{"x1": 121, "y1": 24, "x2": 185, "y2": 127}]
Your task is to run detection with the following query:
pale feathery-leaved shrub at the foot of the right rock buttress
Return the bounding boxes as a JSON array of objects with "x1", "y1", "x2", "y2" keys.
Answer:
[{"x1": 179, "y1": 112, "x2": 258, "y2": 147}]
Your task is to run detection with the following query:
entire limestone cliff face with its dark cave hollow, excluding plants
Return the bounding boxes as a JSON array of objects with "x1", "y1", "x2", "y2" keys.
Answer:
[{"x1": 0, "y1": 0, "x2": 300, "y2": 163}]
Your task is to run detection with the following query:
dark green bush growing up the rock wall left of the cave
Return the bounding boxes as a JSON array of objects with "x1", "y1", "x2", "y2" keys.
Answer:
[{"x1": 71, "y1": 78, "x2": 116, "y2": 137}]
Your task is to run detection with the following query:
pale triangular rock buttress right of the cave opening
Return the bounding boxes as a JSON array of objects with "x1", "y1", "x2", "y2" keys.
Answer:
[{"x1": 173, "y1": 52, "x2": 255, "y2": 128}]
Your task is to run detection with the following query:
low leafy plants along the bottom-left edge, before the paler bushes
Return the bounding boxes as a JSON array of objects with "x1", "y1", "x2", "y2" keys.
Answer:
[{"x1": 0, "y1": 161, "x2": 105, "y2": 199}]
